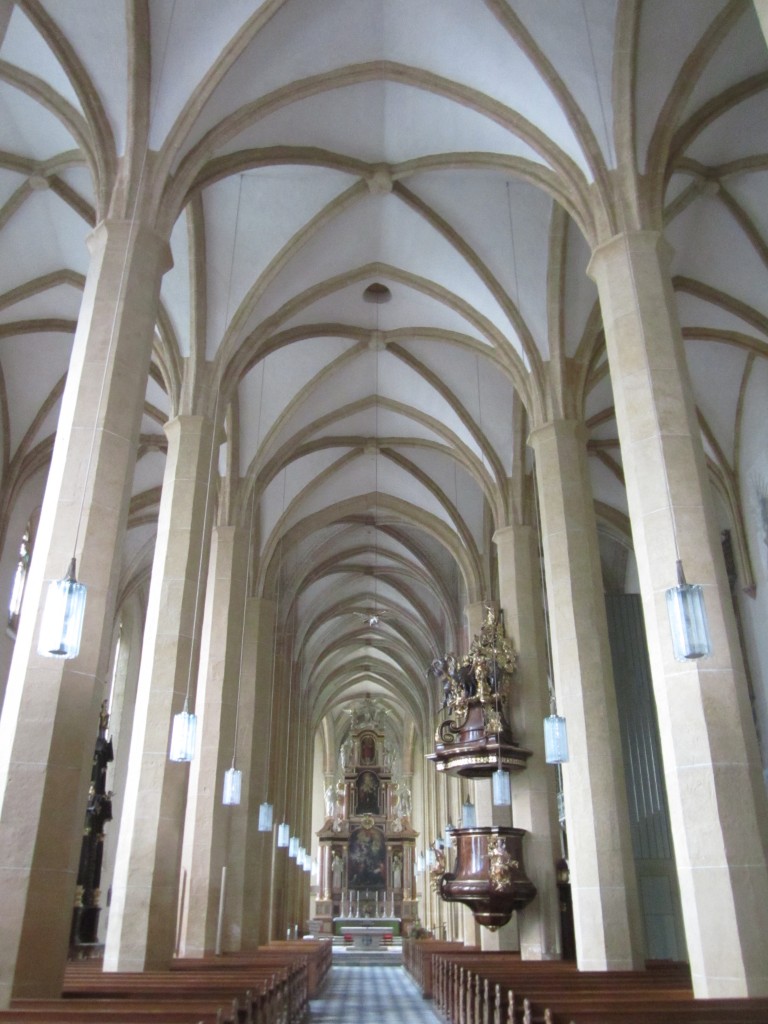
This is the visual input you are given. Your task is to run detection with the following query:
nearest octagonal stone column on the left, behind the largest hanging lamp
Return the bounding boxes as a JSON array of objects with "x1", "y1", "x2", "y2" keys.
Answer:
[{"x1": 0, "y1": 221, "x2": 169, "y2": 1007}]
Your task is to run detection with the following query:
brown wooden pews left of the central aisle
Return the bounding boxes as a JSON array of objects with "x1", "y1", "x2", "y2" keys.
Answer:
[{"x1": 0, "y1": 940, "x2": 332, "y2": 1024}]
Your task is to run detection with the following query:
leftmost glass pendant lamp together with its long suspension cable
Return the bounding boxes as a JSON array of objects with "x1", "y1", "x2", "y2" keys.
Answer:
[{"x1": 37, "y1": 0, "x2": 176, "y2": 659}]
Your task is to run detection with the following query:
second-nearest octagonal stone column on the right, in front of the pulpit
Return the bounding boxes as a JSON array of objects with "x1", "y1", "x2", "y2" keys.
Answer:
[{"x1": 530, "y1": 420, "x2": 643, "y2": 971}]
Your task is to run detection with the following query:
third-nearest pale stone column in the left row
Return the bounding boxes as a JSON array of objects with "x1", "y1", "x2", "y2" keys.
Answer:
[{"x1": 179, "y1": 526, "x2": 247, "y2": 956}]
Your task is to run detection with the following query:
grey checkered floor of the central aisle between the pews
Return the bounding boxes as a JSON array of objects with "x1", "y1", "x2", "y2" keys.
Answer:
[{"x1": 309, "y1": 964, "x2": 441, "y2": 1024}]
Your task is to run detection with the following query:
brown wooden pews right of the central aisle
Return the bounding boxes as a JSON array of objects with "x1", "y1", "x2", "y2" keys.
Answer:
[{"x1": 403, "y1": 939, "x2": 768, "y2": 1024}]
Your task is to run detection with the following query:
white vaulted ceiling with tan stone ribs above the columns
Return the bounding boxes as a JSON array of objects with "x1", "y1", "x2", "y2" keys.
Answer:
[{"x1": 0, "y1": 0, "x2": 768, "y2": 753}]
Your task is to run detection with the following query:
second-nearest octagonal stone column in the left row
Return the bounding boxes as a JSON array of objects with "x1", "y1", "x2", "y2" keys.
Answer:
[{"x1": 104, "y1": 416, "x2": 213, "y2": 971}]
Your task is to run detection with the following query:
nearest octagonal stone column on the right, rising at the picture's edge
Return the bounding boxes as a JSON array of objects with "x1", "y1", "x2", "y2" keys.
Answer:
[{"x1": 590, "y1": 231, "x2": 768, "y2": 996}]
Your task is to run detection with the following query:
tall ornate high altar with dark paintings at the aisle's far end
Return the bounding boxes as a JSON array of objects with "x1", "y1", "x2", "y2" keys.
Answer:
[{"x1": 315, "y1": 698, "x2": 419, "y2": 935}]
